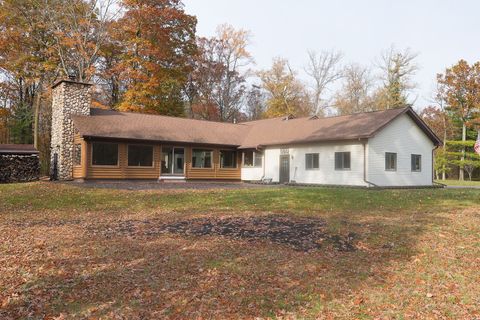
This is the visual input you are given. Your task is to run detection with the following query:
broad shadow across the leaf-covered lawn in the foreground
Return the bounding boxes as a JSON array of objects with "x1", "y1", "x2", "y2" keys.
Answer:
[{"x1": 0, "y1": 211, "x2": 444, "y2": 319}]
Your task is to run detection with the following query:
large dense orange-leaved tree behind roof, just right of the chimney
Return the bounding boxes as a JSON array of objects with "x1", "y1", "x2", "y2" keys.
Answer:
[{"x1": 116, "y1": 0, "x2": 197, "y2": 116}]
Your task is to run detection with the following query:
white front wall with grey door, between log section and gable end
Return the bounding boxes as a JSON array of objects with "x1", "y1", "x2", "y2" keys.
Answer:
[{"x1": 242, "y1": 141, "x2": 366, "y2": 186}]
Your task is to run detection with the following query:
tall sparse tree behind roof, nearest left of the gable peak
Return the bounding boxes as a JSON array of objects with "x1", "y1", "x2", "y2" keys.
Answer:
[{"x1": 375, "y1": 46, "x2": 418, "y2": 110}]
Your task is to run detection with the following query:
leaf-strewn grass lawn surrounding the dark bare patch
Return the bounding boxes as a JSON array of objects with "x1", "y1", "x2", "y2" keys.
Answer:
[{"x1": 0, "y1": 182, "x2": 480, "y2": 319}]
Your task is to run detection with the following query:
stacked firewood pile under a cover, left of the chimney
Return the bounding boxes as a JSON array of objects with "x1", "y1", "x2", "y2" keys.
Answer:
[{"x1": 0, "y1": 154, "x2": 40, "y2": 183}]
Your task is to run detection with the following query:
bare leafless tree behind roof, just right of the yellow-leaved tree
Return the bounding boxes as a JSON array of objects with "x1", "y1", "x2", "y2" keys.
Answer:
[{"x1": 304, "y1": 50, "x2": 343, "y2": 115}]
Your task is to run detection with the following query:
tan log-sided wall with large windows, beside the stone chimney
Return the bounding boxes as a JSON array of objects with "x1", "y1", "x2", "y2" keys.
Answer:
[{"x1": 81, "y1": 137, "x2": 241, "y2": 180}]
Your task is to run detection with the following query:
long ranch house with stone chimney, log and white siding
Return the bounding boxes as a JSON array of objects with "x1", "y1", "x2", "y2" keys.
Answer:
[{"x1": 52, "y1": 80, "x2": 441, "y2": 187}]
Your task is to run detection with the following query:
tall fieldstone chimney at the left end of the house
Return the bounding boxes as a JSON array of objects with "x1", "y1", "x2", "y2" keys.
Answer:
[{"x1": 51, "y1": 80, "x2": 92, "y2": 180}]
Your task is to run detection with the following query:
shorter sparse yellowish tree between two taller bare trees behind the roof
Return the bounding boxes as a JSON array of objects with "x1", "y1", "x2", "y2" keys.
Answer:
[{"x1": 334, "y1": 64, "x2": 376, "y2": 114}]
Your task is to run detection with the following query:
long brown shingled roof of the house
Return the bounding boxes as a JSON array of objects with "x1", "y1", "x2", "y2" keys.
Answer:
[{"x1": 73, "y1": 108, "x2": 441, "y2": 149}]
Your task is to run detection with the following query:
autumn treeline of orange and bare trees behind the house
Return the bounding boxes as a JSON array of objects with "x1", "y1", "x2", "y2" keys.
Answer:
[{"x1": 0, "y1": 0, "x2": 478, "y2": 179}]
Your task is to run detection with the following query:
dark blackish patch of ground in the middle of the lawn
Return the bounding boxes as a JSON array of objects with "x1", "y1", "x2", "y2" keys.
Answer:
[{"x1": 89, "y1": 215, "x2": 357, "y2": 251}]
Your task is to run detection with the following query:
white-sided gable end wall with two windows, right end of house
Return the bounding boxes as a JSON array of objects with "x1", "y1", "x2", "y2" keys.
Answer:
[{"x1": 367, "y1": 115, "x2": 434, "y2": 186}]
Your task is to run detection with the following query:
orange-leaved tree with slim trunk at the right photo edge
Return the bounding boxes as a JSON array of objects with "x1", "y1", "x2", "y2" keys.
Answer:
[{"x1": 437, "y1": 60, "x2": 480, "y2": 180}]
